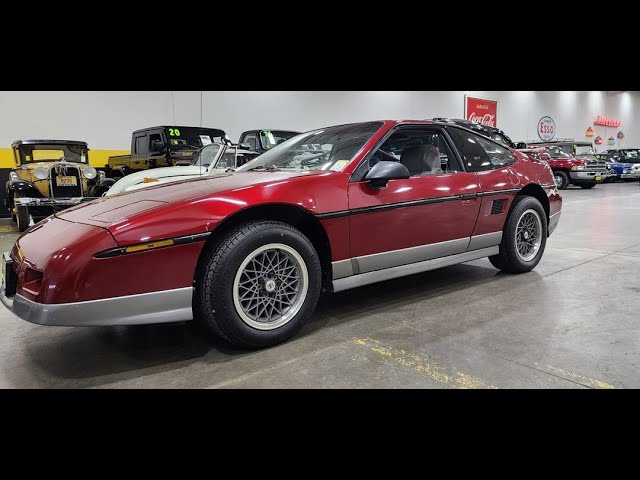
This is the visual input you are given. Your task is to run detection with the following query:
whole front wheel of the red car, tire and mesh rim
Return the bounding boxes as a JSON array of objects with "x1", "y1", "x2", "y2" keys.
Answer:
[{"x1": 193, "y1": 221, "x2": 322, "y2": 348}]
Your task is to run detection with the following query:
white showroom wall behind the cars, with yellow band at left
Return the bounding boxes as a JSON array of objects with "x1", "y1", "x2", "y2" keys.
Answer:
[{"x1": 0, "y1": 91, "x2": 640, "y2": 168}]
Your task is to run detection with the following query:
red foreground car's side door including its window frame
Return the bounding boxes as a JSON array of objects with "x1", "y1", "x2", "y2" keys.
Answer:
[{"x1": 348, "y1": 125, "x2": 480, "y2": 274}]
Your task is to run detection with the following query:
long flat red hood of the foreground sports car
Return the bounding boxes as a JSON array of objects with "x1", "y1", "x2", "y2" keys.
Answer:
[{"x1": 55, "y1": 167, "x2": 335, "y2": 231}]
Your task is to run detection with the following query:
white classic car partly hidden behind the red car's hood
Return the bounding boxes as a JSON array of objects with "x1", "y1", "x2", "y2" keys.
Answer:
[{"x1": 104, "y1": 143, "x2": 258, "y2": 196}]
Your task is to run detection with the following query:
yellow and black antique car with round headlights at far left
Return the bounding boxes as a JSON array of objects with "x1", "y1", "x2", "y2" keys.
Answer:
[{"x1": 5, "y1": 140, "x2": 114, "y2": 232}]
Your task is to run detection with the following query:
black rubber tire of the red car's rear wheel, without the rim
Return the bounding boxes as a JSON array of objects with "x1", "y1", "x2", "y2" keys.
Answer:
[{"x1": 489, "y1": 196, "x2": 547, "y2": 273}]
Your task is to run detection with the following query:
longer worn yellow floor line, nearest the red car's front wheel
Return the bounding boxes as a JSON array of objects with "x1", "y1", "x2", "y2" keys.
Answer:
[{"x1": 353, "y1": 338, "x2": 498, "y2": 388}]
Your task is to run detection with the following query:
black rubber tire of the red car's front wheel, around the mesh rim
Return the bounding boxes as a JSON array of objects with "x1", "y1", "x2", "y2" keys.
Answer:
[{"x1": 193, "y1": 221, "x2": 322, "y2": 348}]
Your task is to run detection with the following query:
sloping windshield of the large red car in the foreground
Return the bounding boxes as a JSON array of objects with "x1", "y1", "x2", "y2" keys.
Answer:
[{"x1": 237, "y1": 122, "x2": 382, "y2": 172}]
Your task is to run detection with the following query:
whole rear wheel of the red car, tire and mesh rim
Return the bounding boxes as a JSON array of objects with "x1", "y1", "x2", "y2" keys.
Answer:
[{"x1": 489, "y1": 196, "x2": 547, "y2": 273}]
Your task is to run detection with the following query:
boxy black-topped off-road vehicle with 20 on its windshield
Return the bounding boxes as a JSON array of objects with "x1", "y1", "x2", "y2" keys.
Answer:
[{"x1": 104, "y1": 125, "x2": 231, "y2": 178}]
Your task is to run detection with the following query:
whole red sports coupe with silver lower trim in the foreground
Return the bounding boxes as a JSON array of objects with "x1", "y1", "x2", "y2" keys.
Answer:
[{"x1": 0, "y1": 121, "x2": 562, "y2": 347}]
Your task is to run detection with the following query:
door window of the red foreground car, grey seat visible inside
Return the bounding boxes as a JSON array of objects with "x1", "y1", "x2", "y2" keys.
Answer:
[{"x1": 358, "y1": 127, "x2": 461, "y2": 177}]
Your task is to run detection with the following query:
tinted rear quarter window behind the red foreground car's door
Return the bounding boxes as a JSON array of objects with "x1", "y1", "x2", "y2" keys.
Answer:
[{"x1": 449, "y1": 128, "x2": 516, "y2": 172}]
